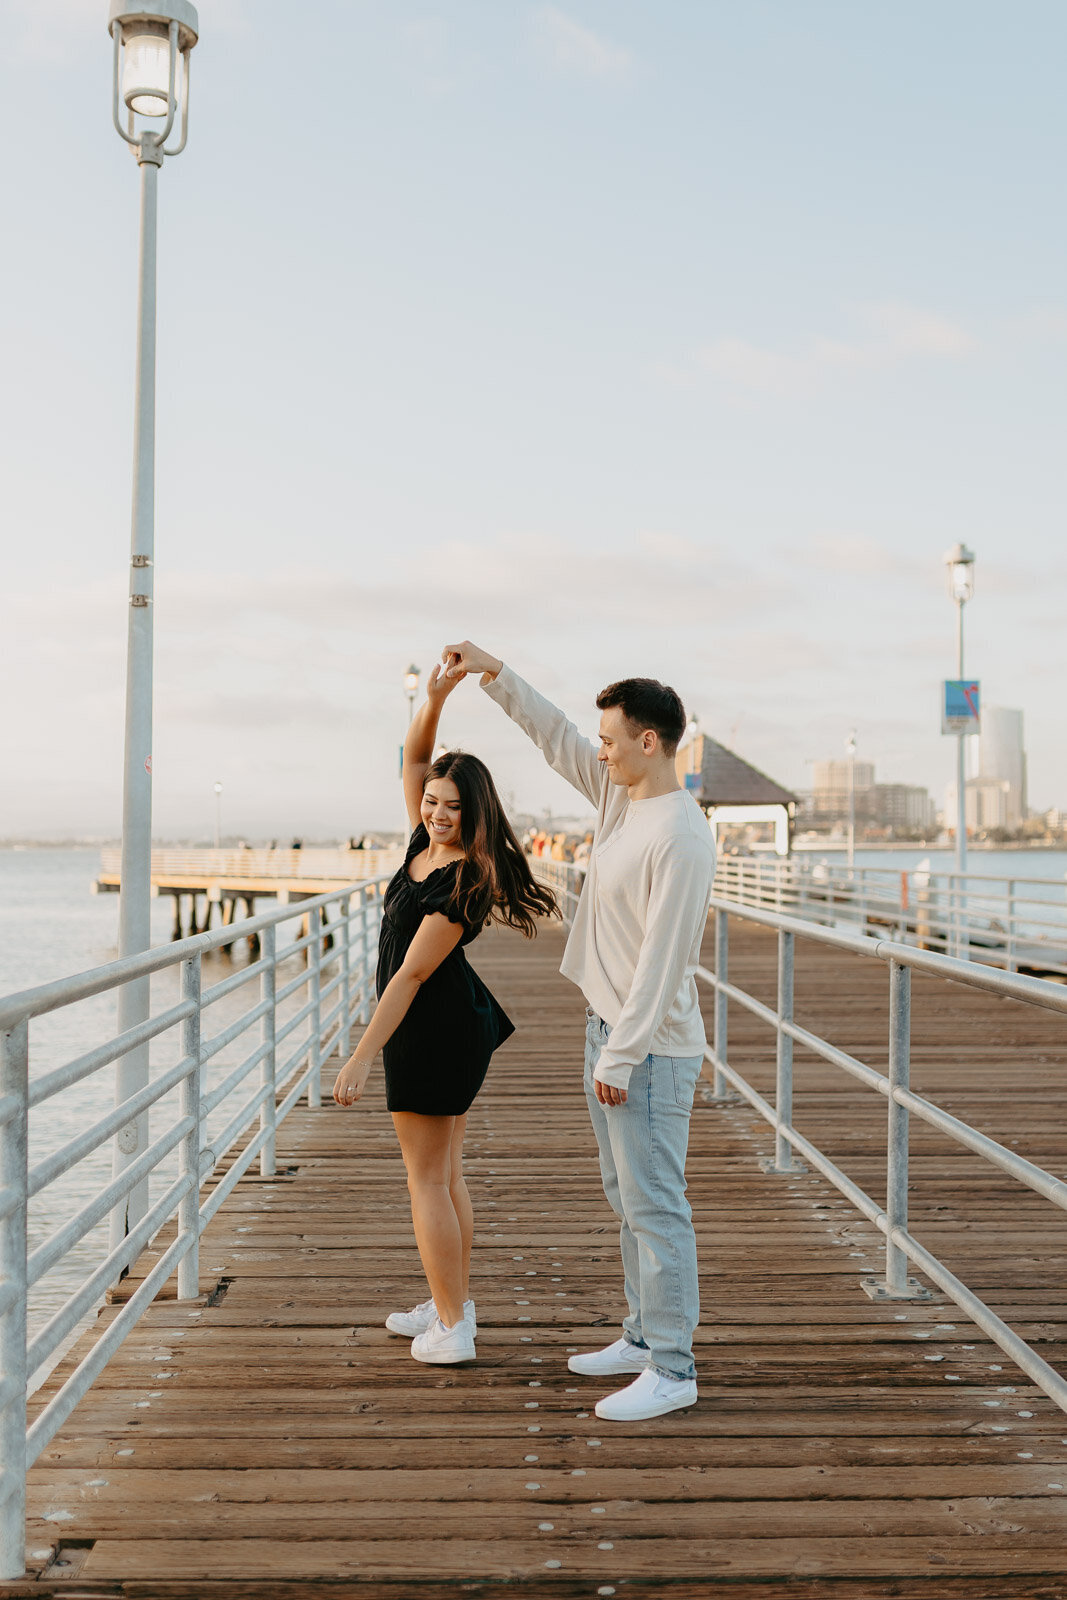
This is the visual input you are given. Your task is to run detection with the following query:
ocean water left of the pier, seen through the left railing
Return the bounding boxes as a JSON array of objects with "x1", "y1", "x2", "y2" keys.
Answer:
[{"x1": 0, "y1": 848, "x2": 347, "y2": 1382}]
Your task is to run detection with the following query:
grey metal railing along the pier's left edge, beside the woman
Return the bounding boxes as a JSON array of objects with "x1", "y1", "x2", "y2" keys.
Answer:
[{"x1": 0, "y1": 880, "x2": 384, "y2": 1579}]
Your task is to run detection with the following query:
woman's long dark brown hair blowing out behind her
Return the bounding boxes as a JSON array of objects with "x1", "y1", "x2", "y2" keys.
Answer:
[{"x1": 424, "y1": 750, "x2": 561, "y2": 939}]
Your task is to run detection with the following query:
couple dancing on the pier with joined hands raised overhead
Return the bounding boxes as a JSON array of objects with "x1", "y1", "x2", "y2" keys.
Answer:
[{"x1": 333, "y1": 642, "x2": 715, "y2": 1421}]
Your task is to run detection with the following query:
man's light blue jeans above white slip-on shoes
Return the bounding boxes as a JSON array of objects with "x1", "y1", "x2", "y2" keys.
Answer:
[{"x1": 585, "y1": 1011, "x2": 704, "y2": 1378}]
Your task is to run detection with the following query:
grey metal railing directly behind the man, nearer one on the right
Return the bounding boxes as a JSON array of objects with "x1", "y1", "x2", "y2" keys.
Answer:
[{"x1": 531, "y1": 859, "x2": 1067, "y2": 1411}]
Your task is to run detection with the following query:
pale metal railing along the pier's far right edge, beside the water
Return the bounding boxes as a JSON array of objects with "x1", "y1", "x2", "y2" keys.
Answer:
[{"x1": 715, "y1": 856, "x2": 1067, "y2": 976}]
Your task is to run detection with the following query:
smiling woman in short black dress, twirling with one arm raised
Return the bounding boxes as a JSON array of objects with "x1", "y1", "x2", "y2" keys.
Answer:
[{"x1": 333, "y1": 649, "x2": 558, "y2": 1363}]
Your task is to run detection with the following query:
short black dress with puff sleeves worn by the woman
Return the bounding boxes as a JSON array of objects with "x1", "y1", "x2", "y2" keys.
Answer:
[{"x1": 376, "y1": 822, "x2": 515, "y2": 1117}]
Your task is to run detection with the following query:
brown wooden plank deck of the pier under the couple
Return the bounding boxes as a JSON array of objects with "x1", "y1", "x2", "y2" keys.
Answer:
[{"x1": 12, "y1": 922, "x2": 1067, "y2": 1600}]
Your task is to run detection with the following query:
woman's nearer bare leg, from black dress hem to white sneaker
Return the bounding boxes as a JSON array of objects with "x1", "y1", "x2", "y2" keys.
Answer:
[{"x1": 392, "y1": 1110, "x2": 466, "y2": 1328}]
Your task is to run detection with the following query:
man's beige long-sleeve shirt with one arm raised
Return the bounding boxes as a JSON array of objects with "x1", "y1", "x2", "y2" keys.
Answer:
[{"x1": 485, "y1": 666, "x2": 715, "y2": 1090}]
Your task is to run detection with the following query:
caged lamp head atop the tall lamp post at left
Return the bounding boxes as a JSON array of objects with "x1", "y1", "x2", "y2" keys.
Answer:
[{"x1": 107, "y1": 0, "x2": 200, "y2": 165}]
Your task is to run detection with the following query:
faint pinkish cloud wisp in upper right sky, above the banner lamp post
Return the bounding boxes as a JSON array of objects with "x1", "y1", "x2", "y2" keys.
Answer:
[{"x1": 696, "y1": 301, "x2": 977, "y2": 394}]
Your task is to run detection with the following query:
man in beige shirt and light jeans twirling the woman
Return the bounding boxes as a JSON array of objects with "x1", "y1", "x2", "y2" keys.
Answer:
[{"x1": 446, "y1": 640, "x2": 715, "y2": 1422}]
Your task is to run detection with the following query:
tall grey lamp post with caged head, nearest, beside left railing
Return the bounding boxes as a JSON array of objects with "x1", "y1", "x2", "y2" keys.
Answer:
[{"x1": 107, "y1": 0, "x2": 200, "y2": 1250}]
